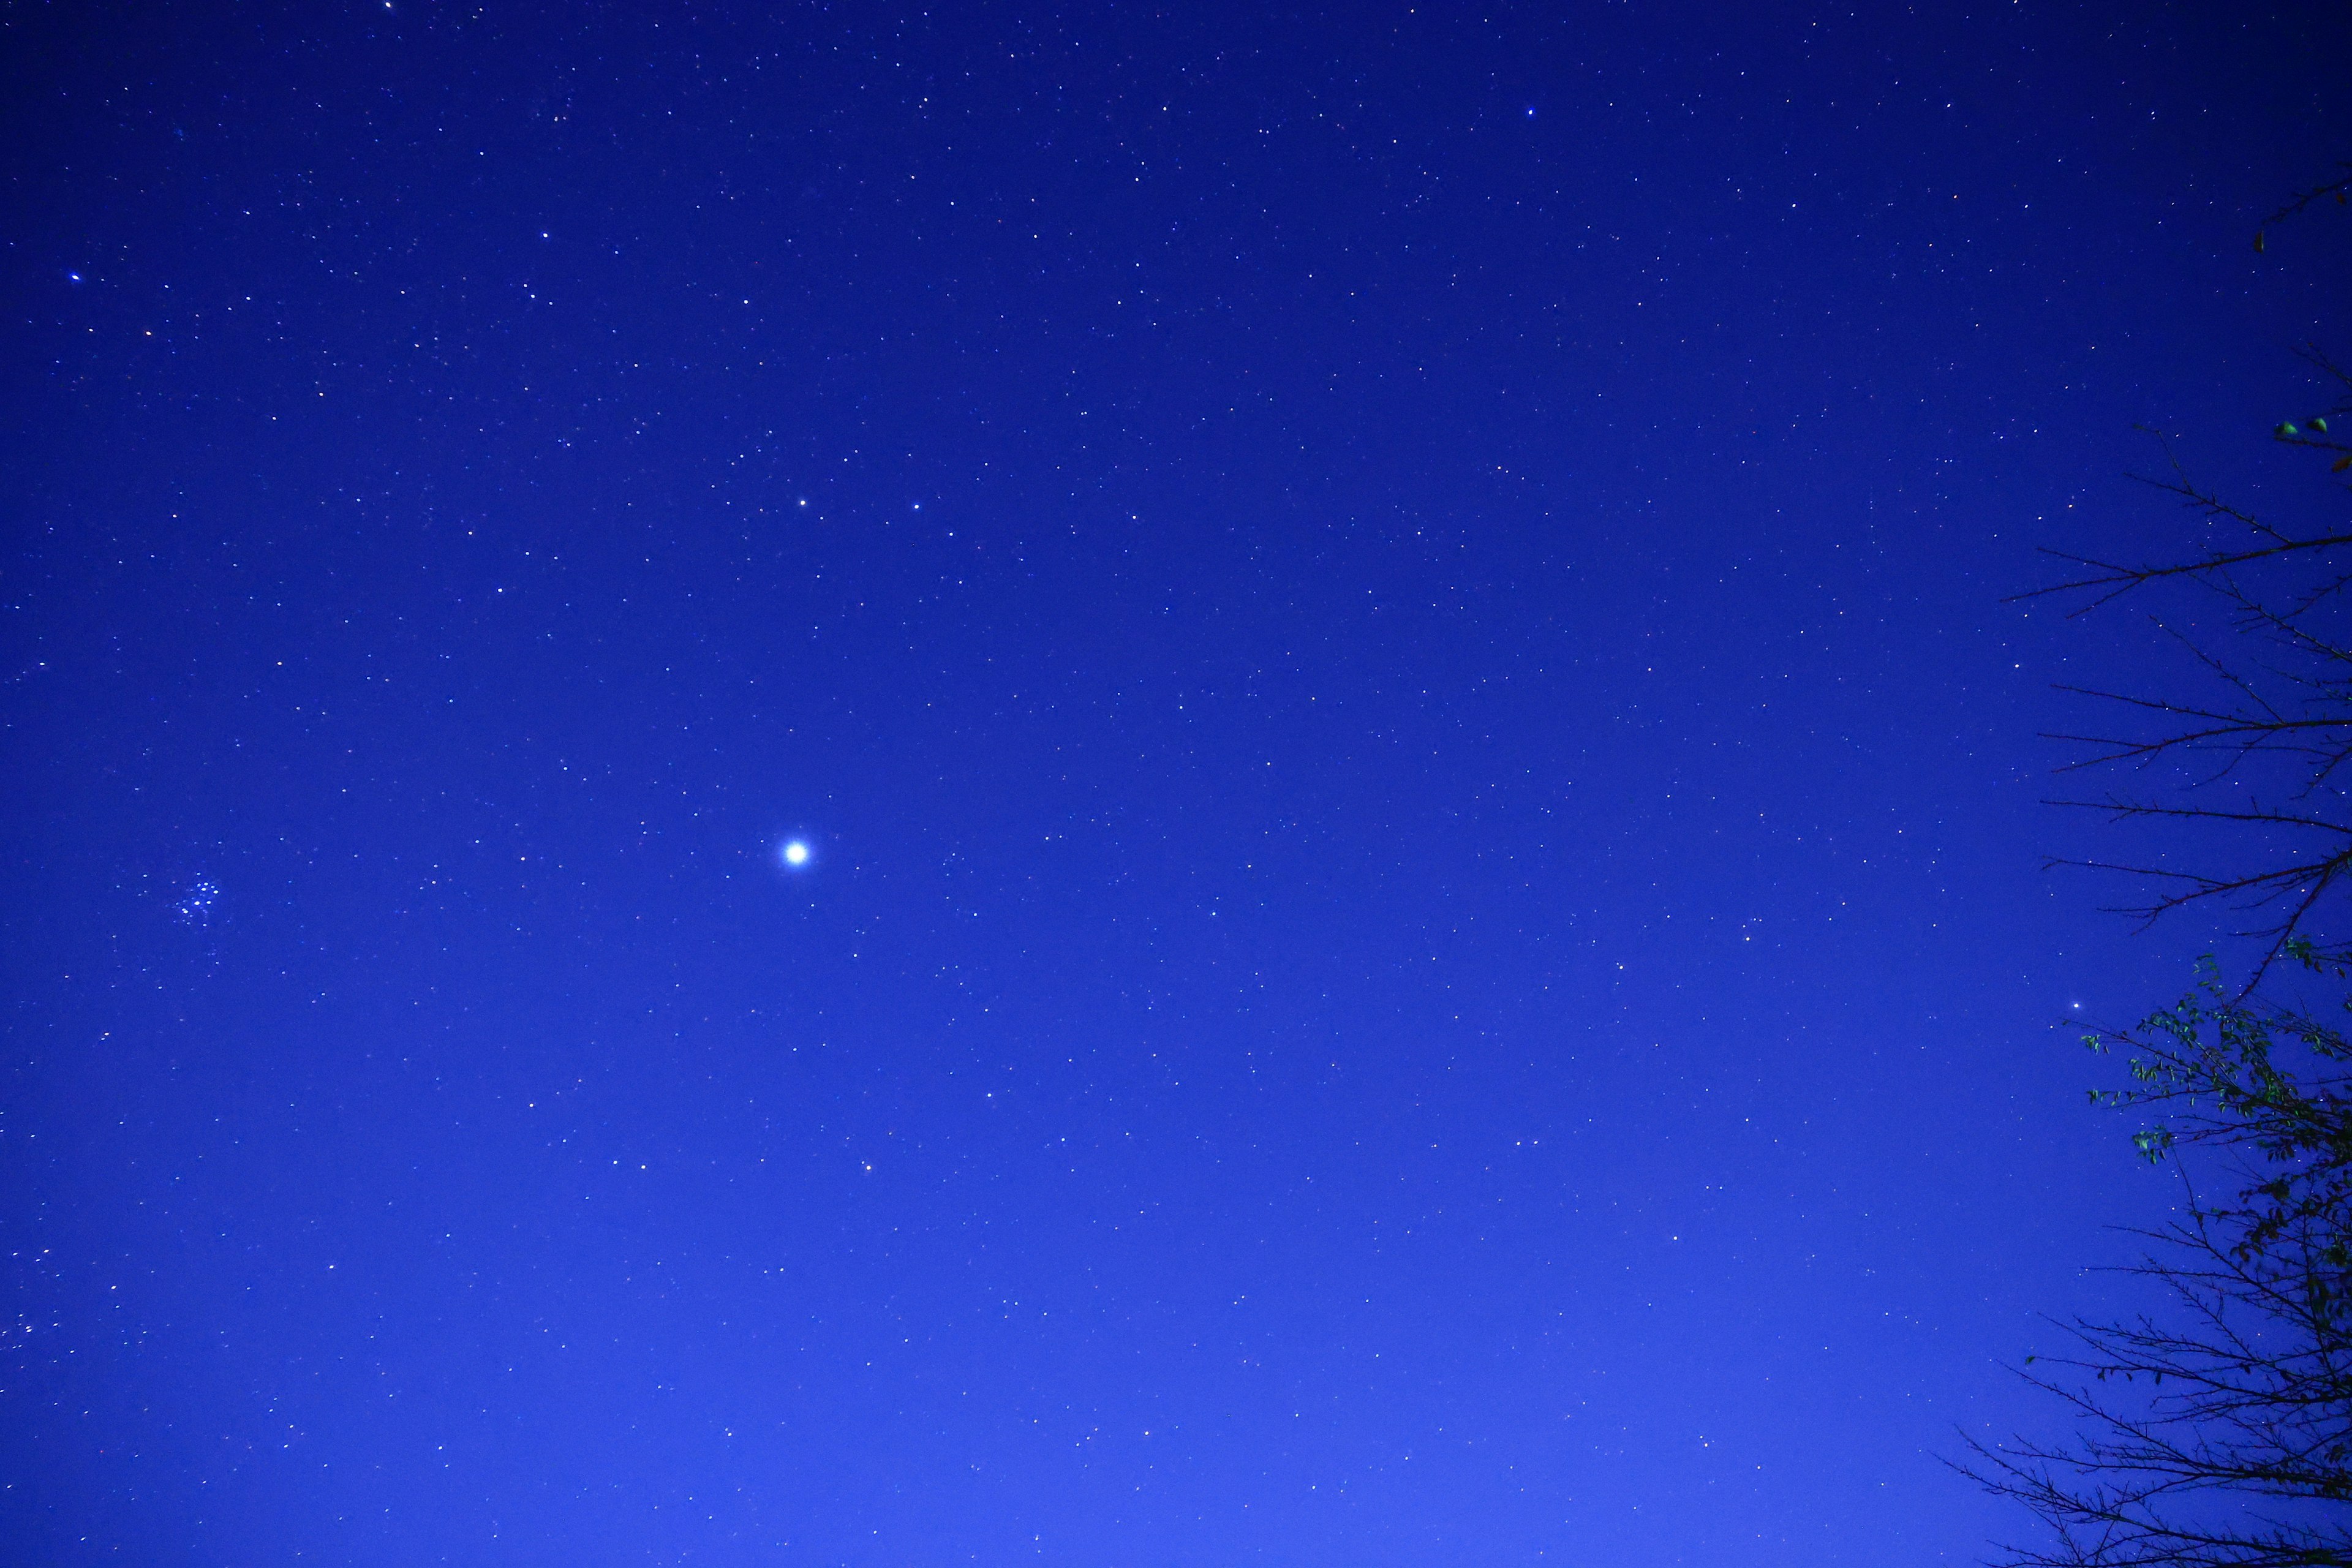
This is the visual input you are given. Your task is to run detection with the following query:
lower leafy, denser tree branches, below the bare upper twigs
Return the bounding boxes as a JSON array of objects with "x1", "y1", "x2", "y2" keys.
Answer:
[{"x1": 1964, "y1": 940, "x2": 2352, "y2": 1568}]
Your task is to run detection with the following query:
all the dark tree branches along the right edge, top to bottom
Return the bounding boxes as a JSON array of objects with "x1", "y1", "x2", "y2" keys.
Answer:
[{"x1": 1962, "y1": 165, "x2": 2352, "y2": 1568}]
